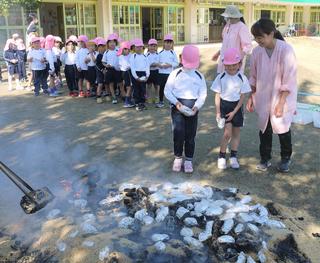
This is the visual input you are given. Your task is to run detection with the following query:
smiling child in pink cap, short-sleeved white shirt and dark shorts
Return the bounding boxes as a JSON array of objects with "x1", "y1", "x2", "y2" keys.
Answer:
[{"x1": 211, "y1": 48, "x2": 251, "y2": 169}]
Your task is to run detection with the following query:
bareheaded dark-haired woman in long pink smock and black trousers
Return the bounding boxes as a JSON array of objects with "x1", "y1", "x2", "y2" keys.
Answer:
[{"x1": 247, "y1": 18, "x2": 297, "y2": 172}]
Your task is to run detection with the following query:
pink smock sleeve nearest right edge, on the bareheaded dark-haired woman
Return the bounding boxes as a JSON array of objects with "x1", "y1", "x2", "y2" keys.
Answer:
[{"x1": 280, "y1": 46, "x2": 297, "y2": 92}]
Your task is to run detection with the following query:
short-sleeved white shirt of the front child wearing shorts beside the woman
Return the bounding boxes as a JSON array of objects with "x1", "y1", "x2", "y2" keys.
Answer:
[{"x1": 210, "y1": 72, "x2": 251, "y2": 101}]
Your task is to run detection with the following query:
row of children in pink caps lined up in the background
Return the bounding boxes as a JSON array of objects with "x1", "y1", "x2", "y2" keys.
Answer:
[{"x1": 22, "y1": 33, "x2": 179, "y2": 111}]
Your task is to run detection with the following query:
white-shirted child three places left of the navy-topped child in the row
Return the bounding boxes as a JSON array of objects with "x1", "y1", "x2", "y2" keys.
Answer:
[{"x1": 61, "y1": 38, "x2": 78, "y2": 97}]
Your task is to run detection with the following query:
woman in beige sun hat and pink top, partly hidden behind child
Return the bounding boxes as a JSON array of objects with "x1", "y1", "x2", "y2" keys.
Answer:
[{"x1": 212, "y1": 5, "x2": 252, "y2": 73}]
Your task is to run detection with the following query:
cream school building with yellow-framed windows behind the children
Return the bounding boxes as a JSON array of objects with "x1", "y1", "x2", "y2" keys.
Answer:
[{"x1": 0, "y1": 0, "x2": 320, "y2": 47}]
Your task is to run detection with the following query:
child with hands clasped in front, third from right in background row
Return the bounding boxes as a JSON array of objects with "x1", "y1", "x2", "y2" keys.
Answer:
[{"x1": 130, "y1": 39, "x2": 150, "y2": 111}]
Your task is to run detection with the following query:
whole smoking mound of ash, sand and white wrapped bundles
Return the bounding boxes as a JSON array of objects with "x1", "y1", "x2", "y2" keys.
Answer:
[{"x1": 0, "y1": 180, "x2": 311, "y2": 263}]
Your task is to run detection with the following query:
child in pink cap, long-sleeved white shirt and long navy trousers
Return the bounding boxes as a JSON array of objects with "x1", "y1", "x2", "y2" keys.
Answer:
[{"x1": 164, "y1": 45, "x2": 207, "y2": 173}]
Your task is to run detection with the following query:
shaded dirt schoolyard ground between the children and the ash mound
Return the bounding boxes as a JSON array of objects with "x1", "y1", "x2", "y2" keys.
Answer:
[{"x1": 0, "y1": 38, "x2": 320, "y2": 263}]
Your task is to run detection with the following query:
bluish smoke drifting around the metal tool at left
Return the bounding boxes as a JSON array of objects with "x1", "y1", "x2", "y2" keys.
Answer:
[{"x1": 0, "y1": 136, "x2": 105, "y2": 232}]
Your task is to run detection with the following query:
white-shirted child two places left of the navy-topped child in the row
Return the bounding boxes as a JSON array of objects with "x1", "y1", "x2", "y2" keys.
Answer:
[{"x1": 76, "y1": 35, "x2": 90, "y2": 98}]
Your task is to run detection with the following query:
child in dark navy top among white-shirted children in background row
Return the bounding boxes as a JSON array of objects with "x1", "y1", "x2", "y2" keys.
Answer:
[{"x1": 96, "y1": 38, "x2": 107, "y2": 104}]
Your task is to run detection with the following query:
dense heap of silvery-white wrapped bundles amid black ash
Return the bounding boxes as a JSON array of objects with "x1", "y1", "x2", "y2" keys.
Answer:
[{"x1": 94, "y1": 183, "x2": 308, "y2": 263}]
